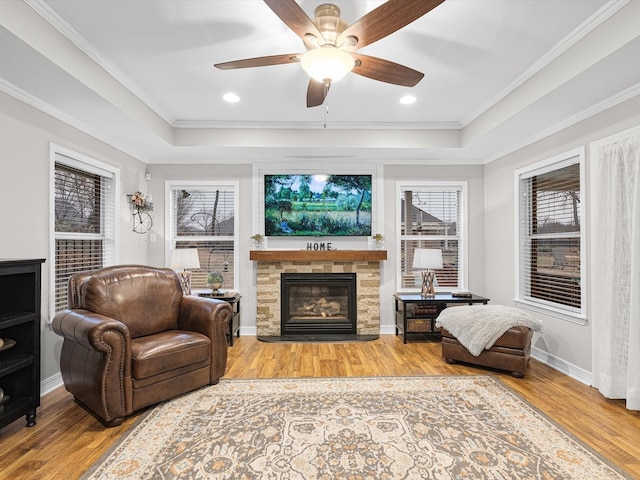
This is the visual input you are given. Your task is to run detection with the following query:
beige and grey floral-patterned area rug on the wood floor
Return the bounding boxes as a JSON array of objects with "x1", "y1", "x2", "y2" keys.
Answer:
[{"x1": 82, "y1": 375, "x2": 631, "y2": 480}]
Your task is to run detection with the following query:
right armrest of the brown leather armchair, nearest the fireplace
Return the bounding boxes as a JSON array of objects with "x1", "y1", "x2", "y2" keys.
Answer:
[{"x1": 178, "y1": 296, "x2": 233, "y2": 385}]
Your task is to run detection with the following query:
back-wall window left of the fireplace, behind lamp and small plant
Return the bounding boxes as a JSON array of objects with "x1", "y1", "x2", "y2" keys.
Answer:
[{"x1": 167, "y1": 182, "x2": 238, "y2": 290}]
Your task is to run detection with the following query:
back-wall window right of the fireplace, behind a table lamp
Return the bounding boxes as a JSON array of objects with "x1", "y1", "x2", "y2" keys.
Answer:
[{"x1": 398, "y1": 182, "x2": 466, "y2": 291}]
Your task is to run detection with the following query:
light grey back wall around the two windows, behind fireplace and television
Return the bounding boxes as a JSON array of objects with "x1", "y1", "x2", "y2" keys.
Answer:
[{"x1": 142, "y1": 163, "x2": 485, "y2": 334}]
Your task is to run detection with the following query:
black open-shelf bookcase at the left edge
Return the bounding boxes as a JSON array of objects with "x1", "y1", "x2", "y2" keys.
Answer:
[{"x1": 0, "y1": 259, "x2": 44, "y2": 428}]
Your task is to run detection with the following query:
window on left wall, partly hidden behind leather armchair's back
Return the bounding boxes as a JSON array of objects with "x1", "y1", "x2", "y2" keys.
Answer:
[{"x1": 50, "y1": 147, "x2": 118, "y2": 314}]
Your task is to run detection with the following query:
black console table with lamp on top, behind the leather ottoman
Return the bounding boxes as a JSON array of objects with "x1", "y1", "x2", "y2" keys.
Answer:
[{"x1": 393, "y1": 293, "x2": 489, "y2": 343}]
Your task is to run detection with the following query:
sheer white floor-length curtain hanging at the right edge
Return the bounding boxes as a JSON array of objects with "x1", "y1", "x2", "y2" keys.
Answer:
[{"x1": 589, "y1": 128, "x2": 640, "y2": 410}]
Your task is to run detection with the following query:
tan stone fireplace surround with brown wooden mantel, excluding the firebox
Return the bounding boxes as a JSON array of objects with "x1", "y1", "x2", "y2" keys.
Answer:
[{"x1": 249, "y1": 250, "x2": 387, "y2": 337}]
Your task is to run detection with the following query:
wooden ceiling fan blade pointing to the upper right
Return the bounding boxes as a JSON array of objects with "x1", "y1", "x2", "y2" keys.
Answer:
[{"x1": 337, "y1": 0, "x2": 444, "y2": 50}]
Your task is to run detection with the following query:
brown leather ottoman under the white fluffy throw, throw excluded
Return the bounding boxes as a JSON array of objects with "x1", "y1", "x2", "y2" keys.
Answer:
[{"x1": 440, "y1": 326, "x2": 533, "y2": 378}]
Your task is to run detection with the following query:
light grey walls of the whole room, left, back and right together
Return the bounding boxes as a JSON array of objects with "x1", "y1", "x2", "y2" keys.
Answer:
[{"x1": 5, "y1": 80, "x2": 640, "y2": 388}]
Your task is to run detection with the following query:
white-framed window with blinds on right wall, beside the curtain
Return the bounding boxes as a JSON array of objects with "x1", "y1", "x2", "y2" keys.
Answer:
[{"x1": 516, "y1": 151, "x2": 584, "y2": 316}]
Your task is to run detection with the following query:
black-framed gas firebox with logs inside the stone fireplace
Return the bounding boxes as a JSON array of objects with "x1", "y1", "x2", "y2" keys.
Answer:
[{"x1": 280, "y1": 273, "x2": 357, "y2": 336}]
